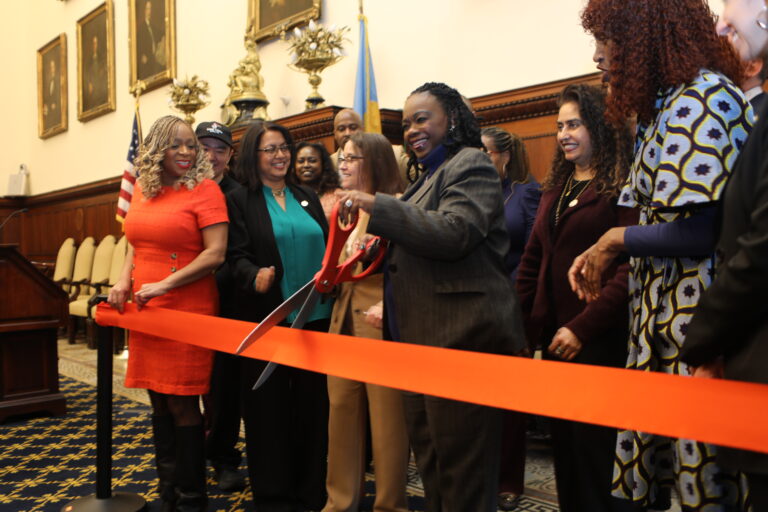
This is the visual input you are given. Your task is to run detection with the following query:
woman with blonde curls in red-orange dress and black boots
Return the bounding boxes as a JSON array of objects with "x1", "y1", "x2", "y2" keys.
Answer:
[{"x1": 109, "y1": 116, "x2": 228, "y2": 511}]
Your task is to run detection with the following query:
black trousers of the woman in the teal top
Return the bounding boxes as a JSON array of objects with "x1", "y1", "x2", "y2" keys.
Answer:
[{"x1": 241, "y1": 320, "x2": 328, "y2": 512}]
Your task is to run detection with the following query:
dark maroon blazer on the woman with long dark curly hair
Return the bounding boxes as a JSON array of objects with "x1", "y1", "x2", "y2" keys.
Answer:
[{"x1": 516, "y1": 186, "x2": 638, "y2": 366}]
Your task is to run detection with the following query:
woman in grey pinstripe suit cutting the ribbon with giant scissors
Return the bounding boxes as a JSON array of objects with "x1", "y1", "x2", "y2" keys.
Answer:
[{"x1": 339, "y1": 83, "x2": 524, "y2": 512}]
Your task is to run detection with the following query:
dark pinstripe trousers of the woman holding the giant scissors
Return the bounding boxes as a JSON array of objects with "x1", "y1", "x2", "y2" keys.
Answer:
[{"x1": 403, "y1": 392, "x2": 501, "y2": 512}]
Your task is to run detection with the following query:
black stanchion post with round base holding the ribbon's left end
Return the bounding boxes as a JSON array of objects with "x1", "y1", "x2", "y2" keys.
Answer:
[{"x1": 61, "y1": 295, "x2": 147, "y2": 512}]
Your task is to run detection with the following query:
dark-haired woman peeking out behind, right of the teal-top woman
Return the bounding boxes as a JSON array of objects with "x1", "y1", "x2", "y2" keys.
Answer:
[{"x1": 295, "y1": 141, "x2": 341, "y2": 219}]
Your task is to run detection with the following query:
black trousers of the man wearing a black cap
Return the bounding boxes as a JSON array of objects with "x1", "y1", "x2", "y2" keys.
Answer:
[{"x1": 205, "y1": 352, "x2": 243, "y2": 468}]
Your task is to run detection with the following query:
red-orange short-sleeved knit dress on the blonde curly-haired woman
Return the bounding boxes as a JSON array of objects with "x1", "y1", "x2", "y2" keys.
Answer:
[{"x1": 125, "y1": 180, "x2": 229, "y2": 395}]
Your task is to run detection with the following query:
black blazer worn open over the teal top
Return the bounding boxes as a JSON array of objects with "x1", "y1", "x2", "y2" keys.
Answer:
[{"x1": 227, "y1": 185, "x2": 328, "y2": 322}]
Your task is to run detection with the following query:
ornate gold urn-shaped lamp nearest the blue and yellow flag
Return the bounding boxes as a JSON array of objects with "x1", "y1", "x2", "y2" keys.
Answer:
[{"x1": 289, "y1": 21, "x2": 349, "y2": 110}]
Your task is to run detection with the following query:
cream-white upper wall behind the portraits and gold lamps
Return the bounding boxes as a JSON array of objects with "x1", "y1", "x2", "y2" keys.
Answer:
[{"x1": 0, "y1": 0, "x2": 721, "y2": 194}]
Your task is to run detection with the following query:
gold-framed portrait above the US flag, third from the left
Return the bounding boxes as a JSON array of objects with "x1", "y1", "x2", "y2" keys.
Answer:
[{"x1": 128, "y1": 0, "x2": 176, "y2": 92}]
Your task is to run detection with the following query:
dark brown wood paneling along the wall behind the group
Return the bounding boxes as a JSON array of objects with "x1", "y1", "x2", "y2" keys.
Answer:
[{"x1": 0, "y1": 73, "x2": 600, "y2": 262}]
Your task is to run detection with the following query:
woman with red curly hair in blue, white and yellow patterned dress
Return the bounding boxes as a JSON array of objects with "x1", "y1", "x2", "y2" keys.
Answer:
[{"x1": 569, "y1": 0, "x2": 753, "y2": 511}]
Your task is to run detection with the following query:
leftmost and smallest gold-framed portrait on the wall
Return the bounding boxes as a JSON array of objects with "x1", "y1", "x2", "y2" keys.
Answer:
[{"x1": 37, "y1": 33, "x2": 67, "y2": 139}]
